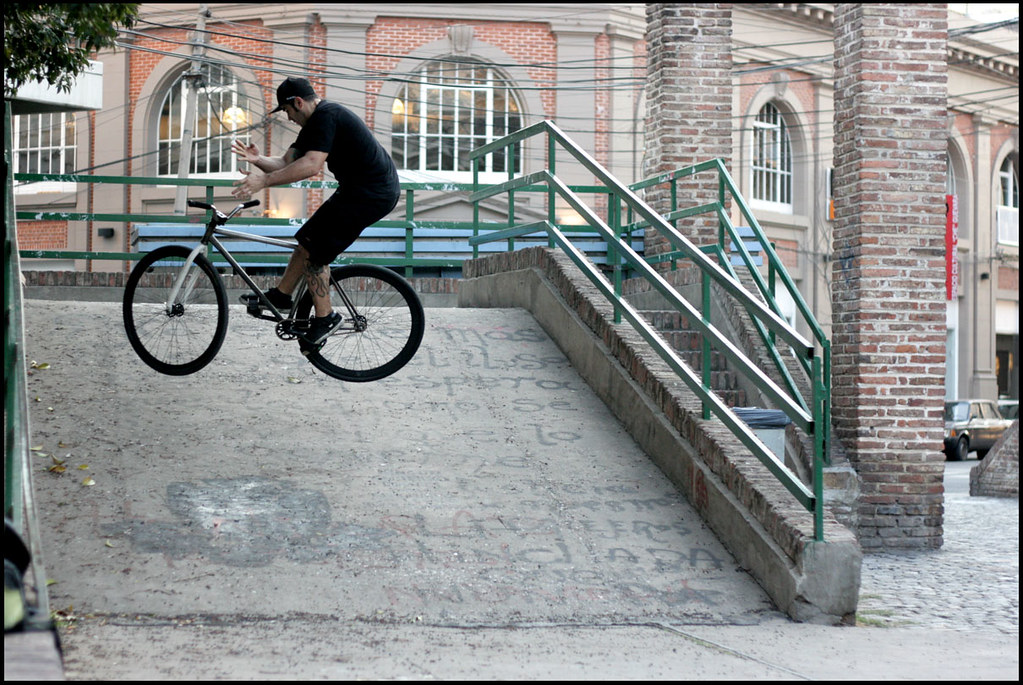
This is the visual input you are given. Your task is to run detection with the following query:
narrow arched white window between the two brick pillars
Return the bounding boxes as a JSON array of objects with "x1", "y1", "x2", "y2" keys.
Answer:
[{"x1": 750, "y1": 102, "x2": 792, "y2": 213}]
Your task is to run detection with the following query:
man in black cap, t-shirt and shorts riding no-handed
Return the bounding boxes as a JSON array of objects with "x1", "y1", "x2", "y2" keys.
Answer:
[{"x1": 231, "y1": 77, "x2": 401, "y2": 345}]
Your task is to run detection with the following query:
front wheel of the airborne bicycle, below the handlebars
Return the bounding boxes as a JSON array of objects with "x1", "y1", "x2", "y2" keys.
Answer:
[{"x1": 123, "y1": 245, "x2": 227, "y2": 376}]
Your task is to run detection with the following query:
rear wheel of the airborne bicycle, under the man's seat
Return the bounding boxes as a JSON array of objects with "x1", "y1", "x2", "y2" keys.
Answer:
[{"x1": 297, "y1": 264, "x2": 426, "y2": 382}]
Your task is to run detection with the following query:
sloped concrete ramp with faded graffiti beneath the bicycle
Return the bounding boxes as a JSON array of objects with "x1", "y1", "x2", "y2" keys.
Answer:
[{"x1": 26, "y1": 301, "x2": 781, "y2": 637}]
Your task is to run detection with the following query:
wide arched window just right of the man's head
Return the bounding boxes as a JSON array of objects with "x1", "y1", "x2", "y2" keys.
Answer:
[{"x1": 391, "y1": 60, "x2": 522, "y2": 180}]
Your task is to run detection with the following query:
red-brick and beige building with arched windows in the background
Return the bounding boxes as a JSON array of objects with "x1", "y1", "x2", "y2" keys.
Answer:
[{"x1": 13, "y1": 3, "x2": 1019, "y2": 399}]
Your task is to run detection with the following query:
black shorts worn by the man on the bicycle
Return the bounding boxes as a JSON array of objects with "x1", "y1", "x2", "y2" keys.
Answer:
[{"x1": 295, "y1": 190, "x2": 400, "y2": 265}]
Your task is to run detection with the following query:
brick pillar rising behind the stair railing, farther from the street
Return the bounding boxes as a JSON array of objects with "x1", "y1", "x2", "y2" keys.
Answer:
[{"x1": 643, "y1": 3, "x2": 733, "y2": 256}]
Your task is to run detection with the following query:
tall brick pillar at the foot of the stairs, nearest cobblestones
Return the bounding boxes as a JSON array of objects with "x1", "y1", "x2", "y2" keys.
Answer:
[{"x1": 832, "y1": 3, "x2": 948, "y2": 550}]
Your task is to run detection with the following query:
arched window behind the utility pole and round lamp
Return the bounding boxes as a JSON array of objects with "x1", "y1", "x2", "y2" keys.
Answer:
[{"x1": 158, "y1": 64, "x2": 251, "y2": 176}]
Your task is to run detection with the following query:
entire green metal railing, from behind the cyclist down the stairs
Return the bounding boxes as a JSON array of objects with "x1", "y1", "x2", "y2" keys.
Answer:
[{"x1": 8, "y1": 132, "x2": 831, "y2": 539}]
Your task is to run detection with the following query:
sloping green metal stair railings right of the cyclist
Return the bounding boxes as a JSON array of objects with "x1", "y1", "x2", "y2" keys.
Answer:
[{"x1": 471, "y1": 122, "x2": 830, "y2": 540}]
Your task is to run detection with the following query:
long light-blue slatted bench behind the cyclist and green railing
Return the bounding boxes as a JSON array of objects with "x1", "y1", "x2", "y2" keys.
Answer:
[{"x1": 132, "y1": 223, "x2": 642, "y2": 268}]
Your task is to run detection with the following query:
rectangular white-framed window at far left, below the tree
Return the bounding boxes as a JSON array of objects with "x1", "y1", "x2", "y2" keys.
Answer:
[{"x1": 11, "y1": 111, "x2": 78, "y2": 195}]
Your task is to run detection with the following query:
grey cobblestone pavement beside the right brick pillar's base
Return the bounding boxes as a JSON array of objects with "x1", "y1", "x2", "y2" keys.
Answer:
[{"x1": 858, "y1": 455, "x2": 1020, "y2": 635}]
